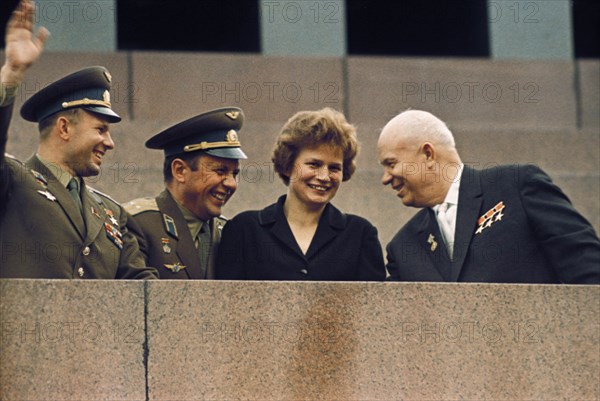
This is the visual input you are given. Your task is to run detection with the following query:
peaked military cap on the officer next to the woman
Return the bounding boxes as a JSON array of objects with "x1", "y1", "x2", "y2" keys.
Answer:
[{"x1": 146, "y1": 107, "x2": 247, "y2": 159}]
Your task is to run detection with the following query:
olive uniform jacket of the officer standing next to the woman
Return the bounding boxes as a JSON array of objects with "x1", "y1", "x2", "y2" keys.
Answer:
[{"x1": 123, "y1": 189, "x2": 227, "y2": 280}]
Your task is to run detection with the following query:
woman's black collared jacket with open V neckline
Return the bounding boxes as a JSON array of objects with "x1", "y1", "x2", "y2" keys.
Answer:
[{"x1": 217, "y1": 196, "x2": 386, "y2": 281}]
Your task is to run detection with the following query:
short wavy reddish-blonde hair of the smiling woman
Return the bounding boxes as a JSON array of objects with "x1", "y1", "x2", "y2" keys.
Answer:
[{"x1": 271, "y1": 107, "x2": 358, "y2": 185}]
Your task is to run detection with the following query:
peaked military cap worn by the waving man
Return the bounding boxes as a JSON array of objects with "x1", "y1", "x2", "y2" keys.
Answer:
[{"x1": 21, "y1": 66, "x2": 121, "y2": 122}]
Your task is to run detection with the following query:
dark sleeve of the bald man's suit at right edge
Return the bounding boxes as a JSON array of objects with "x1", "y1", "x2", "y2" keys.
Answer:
[{"x1": 519, "y1": 165, "x2": 600, "y2": 284}]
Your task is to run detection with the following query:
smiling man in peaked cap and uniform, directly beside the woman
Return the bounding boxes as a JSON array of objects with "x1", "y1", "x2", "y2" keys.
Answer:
[{"x1": 124, "y1": 107, "x2": 246, "y2": 279}]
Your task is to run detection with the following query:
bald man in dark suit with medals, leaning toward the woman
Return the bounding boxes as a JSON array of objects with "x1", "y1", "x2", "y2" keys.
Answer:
[{"x1": 377, "y1": 110, "x2": 600, "y2": 284}]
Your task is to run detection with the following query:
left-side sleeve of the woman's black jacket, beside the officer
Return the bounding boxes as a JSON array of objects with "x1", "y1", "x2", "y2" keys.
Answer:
[{"x1": 215, "y1": 218, "x2": 246, "y2": 280}]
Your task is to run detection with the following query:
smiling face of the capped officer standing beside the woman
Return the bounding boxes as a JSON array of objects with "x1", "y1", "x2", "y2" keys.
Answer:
[{"x1": 172, "y1": 154, "x2": 240, "y2": 221}]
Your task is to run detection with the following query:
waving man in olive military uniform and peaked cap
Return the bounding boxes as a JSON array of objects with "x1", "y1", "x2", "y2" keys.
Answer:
[{"x1": 0, "y1": 0, "x2": 157, "y2": 279}]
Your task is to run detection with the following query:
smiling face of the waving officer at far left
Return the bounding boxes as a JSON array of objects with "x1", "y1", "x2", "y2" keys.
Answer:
[{"x1": 62, "y1": 110, "x2": 115, "y2": 177}]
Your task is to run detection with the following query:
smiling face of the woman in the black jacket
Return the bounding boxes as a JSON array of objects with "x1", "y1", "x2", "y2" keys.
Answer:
[{"x1": 287, "y1": 144, "x2": 344, "y2": 208}]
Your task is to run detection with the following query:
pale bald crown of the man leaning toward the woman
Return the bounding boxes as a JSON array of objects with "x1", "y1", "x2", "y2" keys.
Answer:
[{"x1": 380, "y1": 110, "x2": 455, "y2": 148}]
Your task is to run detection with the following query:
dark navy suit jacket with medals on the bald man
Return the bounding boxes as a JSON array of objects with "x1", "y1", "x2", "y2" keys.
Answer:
[{"x1": 387, "y1": 165, "x2": 600, "y2": 284}]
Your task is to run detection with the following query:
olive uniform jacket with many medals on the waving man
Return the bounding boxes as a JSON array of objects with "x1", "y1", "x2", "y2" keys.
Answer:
[{"x1": 0, "y1": 105, "x2": 157, "y2": 279}]
